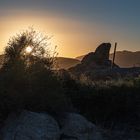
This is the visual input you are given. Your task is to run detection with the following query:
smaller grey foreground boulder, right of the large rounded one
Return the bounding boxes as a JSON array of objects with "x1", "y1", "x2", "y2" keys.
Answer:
[{"x1": 60, "y1": 113, "x2": 102, "y2": 140}]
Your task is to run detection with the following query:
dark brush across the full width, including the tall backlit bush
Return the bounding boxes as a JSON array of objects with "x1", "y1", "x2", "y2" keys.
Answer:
[{"x1": 0, "y1": 29, "x2": 140, "y2": 135}]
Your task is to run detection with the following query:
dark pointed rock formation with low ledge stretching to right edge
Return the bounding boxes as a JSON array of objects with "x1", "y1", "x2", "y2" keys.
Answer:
[{"x1": 69, "y1": 43, "x2": 140, "y2": 80}]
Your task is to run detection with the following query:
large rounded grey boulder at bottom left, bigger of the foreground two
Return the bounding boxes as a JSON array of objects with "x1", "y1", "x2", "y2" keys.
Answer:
[{"x1": 1, "y1": 111, "x2": 60, "y2": 140}]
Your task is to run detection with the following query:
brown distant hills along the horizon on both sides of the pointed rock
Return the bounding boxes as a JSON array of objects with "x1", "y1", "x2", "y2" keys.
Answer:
[{"x1": 0, "y1": 50, "x2": 140, "y2": 69}]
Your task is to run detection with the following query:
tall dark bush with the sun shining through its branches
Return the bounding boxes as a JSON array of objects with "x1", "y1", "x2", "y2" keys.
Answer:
[{"x1": 0, "y1": 29, "x2": 68, "y2": 118}]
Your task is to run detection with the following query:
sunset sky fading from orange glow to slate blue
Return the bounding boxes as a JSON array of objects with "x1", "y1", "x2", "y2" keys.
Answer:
[{"x1": 0, "y1": 0, "x2": 140, "y2": 57}]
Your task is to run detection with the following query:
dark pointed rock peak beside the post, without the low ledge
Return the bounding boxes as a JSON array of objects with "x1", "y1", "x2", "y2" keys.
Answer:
[{"x1": 69, "y1": 43, "x2": 118, "y2": 73}]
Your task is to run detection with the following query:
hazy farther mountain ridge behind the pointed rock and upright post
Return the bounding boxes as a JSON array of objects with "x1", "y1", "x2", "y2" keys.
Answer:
[{"x1": 76, "y1": 51, "x2": 140, "y2": 67}]
